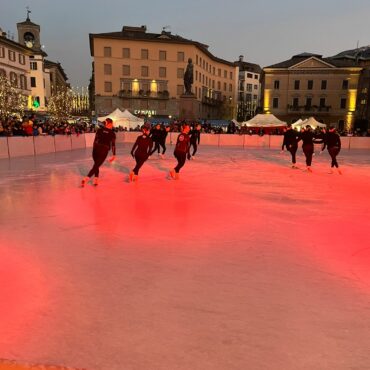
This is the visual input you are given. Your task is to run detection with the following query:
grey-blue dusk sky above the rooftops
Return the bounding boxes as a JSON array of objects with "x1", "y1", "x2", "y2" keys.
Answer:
[{"x1": 0, "y1": 0, "x2": 370, "y2": 86}]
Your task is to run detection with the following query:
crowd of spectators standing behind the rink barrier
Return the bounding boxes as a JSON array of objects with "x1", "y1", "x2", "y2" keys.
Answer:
[{"x1": 0, "y1": 115, "x2": 370, "y2": 136}]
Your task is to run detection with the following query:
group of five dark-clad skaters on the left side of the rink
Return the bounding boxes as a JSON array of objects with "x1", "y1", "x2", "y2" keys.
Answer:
[{"x1": 81, "y1": 118, "x2": 201, "y2": 187}]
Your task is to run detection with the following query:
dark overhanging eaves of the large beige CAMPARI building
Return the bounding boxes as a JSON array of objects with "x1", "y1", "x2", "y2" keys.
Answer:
[{"x1": 89, "y1": 33, "x2": 237, "y2": 67}]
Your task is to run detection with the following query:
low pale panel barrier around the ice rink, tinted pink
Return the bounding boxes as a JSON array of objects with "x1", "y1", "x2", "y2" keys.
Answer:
[{"x1": 0, "y1": 132, "x2": 370, "y2": 159}]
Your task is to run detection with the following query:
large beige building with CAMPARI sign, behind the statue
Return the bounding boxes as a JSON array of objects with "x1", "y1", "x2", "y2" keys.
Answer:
[{"x1": 90, "y1": 26, "x2": 238, "y2": 119}]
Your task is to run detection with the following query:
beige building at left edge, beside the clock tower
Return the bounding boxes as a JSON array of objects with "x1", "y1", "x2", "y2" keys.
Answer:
[{"x1": 0, "y1": 29, "x2": 32, "y2": 96}]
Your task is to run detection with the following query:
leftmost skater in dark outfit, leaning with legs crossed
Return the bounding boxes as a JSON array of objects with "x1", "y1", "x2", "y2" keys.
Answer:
[{"x1": 81, "y1": 118, "x2": 116, "y2": 187}]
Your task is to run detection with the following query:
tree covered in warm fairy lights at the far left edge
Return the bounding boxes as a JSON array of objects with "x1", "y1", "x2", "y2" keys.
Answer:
[{"x1": 0, "y1": 75, "x2": 27, "y2": 119}]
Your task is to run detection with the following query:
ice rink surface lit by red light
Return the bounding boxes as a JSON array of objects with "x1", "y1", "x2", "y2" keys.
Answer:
[{"x1": 0, "y1": 145, "x2": 370, "y2": 370}]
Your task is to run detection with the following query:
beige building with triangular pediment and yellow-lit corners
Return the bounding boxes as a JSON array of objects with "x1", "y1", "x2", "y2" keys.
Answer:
[{"x1": 263, "y1": 53, "x2": 363, "y2": 129}]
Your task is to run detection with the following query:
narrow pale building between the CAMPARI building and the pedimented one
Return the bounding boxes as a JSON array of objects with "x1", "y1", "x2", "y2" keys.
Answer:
[{"x1": 235, "y1": 55, "x2": 262, "y2": 122}]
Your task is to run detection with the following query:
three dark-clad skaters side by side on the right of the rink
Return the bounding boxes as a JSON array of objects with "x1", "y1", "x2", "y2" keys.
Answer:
[{"x1": 281, "y1": 124, "x2": 342, "y2": 175}]
